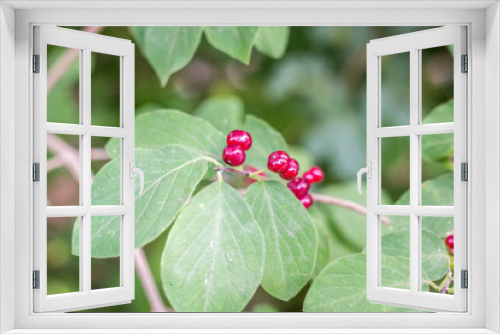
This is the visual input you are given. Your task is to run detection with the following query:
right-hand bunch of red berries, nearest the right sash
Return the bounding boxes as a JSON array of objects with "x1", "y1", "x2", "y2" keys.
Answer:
[{"x1": 267, "y1": 151, "x2": 323, "y2": 209}]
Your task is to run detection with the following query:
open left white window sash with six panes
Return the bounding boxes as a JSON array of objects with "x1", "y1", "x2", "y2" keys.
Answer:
[{"x1": 33, "y1": 26, "x2": 135, "y2": 312}]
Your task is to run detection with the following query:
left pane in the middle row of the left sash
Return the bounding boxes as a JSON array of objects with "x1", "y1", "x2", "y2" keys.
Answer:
[{"x1": 47, "y1": 134, "x2": 80, "y2": 206}]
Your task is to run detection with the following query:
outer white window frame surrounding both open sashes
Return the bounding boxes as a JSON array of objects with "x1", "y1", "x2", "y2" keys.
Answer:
[{"x1": 0, "y1": 0, "x2": 500, "y2": 333}]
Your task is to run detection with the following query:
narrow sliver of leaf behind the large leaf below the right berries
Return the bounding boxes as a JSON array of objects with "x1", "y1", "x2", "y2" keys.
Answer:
[{"x1": 309, "y1": 205, "x2": 335, "y2": 277}]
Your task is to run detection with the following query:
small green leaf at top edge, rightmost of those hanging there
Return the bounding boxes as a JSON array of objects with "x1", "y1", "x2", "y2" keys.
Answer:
[{"x1": 255, "y1": 26, "x2": 290, "y2": 59}]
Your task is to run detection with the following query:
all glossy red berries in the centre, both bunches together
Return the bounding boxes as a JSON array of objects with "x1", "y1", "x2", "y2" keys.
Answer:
[{"x1": 222, "y1": 130, "x2": 323, "y2": 209}]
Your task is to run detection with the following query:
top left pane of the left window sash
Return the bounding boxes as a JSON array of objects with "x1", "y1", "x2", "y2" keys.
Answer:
[{"x1": 47, "y1": 45, "x2": 80, "y2": 124}]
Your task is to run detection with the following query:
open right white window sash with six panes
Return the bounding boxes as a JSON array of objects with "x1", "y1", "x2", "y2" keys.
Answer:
[{"x1": 367, "y1": 26, "x2": 467, "y2": 311}]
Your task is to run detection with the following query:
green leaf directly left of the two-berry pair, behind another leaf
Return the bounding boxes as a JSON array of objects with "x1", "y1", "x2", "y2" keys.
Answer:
[{"x1": 106, "y1": 109, "x2": 226, "y2": 158}]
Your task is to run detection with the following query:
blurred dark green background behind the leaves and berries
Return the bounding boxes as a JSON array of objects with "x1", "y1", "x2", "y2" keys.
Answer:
[{"x1": 47, "y1": 27, "x2": 453, "y2": 312}]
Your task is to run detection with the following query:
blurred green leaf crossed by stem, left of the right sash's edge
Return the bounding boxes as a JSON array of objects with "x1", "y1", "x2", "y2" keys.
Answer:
[{"x1": 319, "y1": 182, "x2": 390, "y2": 251}]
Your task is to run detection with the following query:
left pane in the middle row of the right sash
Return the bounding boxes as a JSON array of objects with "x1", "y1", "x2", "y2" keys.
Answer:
[{"x1": 381, "y1": 137, "x2": 410, "y2": 205}]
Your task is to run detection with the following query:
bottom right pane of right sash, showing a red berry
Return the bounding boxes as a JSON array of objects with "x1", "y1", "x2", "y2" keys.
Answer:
[{"x1": 421, "y1": 217, "x2": 454, "y2": 294}]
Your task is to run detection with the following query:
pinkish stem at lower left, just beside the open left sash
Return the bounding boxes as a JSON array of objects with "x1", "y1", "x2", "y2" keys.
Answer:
[{"x1": 135, "y1": 248, "x2": 175, "y2": 312}]
